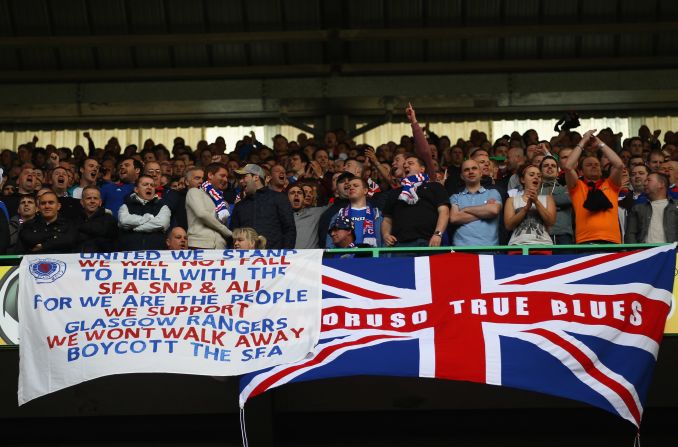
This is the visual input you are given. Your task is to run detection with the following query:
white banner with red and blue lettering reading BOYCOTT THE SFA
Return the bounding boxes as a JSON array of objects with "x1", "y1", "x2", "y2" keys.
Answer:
[{"x1": 19, "y1": 250, "x2": 322, "y2": 405}]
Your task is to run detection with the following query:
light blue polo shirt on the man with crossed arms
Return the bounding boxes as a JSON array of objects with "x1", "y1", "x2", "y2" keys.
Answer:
[{"x1": 450, "y1": 186, "x2": 501, "y2": 246}]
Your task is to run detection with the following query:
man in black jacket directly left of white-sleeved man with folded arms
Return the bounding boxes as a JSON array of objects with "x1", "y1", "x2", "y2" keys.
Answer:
[{"x1": 78, "y1": 185, "x2": 118, "y2": 253}]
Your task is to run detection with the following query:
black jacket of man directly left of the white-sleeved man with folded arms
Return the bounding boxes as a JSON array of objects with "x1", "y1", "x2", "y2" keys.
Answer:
[{"x1": 78, "y1": 207, "x2": 118, "y2": 253}]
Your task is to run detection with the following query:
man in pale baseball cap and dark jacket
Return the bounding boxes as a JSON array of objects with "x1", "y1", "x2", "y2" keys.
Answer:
[{"x1": 231, "y1": 164, "x2": 297, "y2": 249}]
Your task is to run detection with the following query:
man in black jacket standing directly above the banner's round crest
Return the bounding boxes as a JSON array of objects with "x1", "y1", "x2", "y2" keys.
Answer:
[{"x1": 18, "y1": 190, "x2": 78, "y2": 254}]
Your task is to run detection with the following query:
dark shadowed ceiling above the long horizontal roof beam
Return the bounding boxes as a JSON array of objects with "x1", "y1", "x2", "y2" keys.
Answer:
[{"x1": 0, "y1": 0, "x2": 678, "y2": 81}]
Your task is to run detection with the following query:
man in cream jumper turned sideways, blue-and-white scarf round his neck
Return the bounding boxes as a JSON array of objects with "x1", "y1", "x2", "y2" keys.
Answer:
[{"x1": 186, "y1": 163, "x2": 231, "y2": 249}]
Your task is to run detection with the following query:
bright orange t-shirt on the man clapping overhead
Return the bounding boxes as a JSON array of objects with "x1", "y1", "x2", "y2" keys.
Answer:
[{"x1": 569, "y1": 179, "x2": 621, "y2": 244}]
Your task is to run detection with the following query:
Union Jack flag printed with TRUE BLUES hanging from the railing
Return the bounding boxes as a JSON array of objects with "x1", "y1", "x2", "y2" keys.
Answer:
[{"x1": 240, "y1": 245, "x2": 676, "y2": 426}]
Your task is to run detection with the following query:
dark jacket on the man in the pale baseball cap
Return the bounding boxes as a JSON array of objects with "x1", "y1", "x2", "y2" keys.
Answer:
[{"x1": 231, "y1": 187, "x2": 297, "y2": 248}]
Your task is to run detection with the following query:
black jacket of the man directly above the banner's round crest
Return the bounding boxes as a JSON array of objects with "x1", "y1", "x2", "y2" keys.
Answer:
[{"x1": 17, "y1": 215, "x2": 78, "y2": 254}]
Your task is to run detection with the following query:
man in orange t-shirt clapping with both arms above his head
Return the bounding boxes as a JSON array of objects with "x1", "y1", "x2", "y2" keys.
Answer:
[{"x1": 565, "y1": 130, "x2": 624, "y2": 244}]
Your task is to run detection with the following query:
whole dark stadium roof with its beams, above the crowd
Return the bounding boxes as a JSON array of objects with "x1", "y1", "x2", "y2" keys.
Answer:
[{"x1": 0, "y1": 0, "x2": 678, "y2": 128}]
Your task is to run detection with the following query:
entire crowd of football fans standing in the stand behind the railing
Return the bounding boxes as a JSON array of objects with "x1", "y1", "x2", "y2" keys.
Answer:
[{"x1": 0, "y1": 106, "x2": 678, "y2": 254}]
